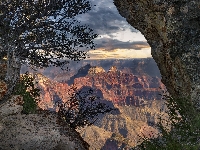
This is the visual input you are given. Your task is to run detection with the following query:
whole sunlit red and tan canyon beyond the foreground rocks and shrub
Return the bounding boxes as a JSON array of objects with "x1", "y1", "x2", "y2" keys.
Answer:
[{"x1": 30, "y1": 59, "x2": 167, "y2": 150}]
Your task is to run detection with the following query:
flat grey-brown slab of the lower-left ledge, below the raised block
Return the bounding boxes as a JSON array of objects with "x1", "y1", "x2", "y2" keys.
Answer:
[{"x1": 0, "y1": 114, "x2": 88, "y2": 150}]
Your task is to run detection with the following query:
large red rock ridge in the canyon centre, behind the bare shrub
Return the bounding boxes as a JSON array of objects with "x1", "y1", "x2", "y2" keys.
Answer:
[{"x1": 74, "y1": 67, "x2": 165, "y2": 106}]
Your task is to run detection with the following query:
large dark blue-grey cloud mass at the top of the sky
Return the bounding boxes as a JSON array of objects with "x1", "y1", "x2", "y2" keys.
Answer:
[{"x1": 77, "y1": 0, "x2": 138, "y2": 37}]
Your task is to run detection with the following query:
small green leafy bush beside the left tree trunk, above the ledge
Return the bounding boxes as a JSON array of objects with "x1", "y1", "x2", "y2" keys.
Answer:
[{"x1": 14, "y1": 72, "x2": 40, "y2": 114}]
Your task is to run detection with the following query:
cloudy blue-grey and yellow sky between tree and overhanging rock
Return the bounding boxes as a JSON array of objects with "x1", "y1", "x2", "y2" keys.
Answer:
[{"x1": 77, "y1": 0, "x2": 152, "y2": 59}]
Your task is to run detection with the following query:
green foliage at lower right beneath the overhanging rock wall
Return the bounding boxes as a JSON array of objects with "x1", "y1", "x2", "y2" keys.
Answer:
[{"x1": 134, "y1": 90, "x2": 200, "y2": 150}]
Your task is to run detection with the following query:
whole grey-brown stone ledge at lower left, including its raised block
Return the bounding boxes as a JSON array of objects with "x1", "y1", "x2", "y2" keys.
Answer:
[{"x1": 0, "y1": 82, "x2": 89, "y2": 150}]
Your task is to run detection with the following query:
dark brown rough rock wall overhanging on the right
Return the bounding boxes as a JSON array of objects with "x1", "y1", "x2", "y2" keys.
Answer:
[{"x1": 114, "y1": 0, "x2": 200, "y2": 110}]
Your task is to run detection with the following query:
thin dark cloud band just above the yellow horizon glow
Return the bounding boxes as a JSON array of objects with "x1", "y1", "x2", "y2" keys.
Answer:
[{"x1": 96, "y1": 38, "x2": 149, "y2": 51}]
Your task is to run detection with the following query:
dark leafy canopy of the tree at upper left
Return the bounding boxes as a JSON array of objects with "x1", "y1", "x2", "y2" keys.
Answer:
[{"x1": 0, "y1": 0, "x2": 98, "y2": 68}]
